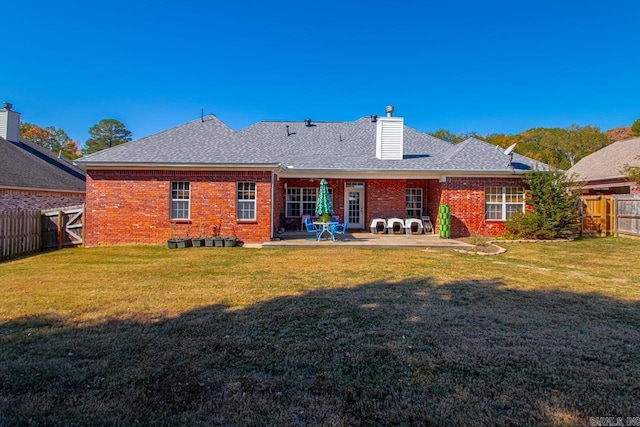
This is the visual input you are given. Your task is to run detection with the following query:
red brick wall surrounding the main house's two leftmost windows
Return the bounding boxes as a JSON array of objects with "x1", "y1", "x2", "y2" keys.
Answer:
[{"x1": 85, "y1": 170, "x2": 271, "y2": 246}]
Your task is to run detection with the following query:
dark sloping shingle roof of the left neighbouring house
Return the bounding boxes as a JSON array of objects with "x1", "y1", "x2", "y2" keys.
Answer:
[{"x1": 0, "y1": 137, "x2": 85, "y2": 192}]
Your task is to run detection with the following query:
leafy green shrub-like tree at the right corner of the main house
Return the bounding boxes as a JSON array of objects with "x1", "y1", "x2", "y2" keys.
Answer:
[{"x1": 524, "y1": 170, "x2": 582, "y2": 237}]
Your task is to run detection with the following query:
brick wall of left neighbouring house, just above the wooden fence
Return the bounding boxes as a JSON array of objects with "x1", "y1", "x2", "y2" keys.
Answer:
[{"x1": 0, "y1": 189, "x2": 84, "y2": 211}]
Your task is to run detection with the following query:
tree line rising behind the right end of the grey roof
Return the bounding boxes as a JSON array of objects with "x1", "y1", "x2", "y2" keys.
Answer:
[{"x1": 430, "y1": 119, "x2": 640, "y2": 170}]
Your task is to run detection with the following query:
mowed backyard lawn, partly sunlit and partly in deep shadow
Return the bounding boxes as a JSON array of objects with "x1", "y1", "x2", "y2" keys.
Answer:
[{"x1": 0, "y1": 238, "x2": 640, "y2": 426}]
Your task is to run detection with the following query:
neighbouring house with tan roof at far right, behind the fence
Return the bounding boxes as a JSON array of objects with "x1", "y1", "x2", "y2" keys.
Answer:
[{"x1": 567, "y1": 138, "x2": 640, "y2": 195}]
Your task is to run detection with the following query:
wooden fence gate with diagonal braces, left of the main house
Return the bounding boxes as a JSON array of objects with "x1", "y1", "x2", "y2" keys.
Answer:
[{"x1": 42, "y1": 205, "x2": 84, "y2": 249}]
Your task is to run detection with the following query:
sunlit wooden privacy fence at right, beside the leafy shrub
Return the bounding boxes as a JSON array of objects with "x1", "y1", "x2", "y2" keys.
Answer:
[{"x1": 580, "y1": 194, "x2": 640, "y2": 236}]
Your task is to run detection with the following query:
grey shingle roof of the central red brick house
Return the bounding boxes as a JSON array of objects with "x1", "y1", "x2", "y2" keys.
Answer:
[{"x1": 77, "y1": 115, "x2": 545, "y2": 174}]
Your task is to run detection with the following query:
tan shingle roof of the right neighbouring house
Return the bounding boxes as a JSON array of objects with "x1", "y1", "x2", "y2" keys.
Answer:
[{"x1": 567, "y1": 138, "x2": 640, "y2": 182}]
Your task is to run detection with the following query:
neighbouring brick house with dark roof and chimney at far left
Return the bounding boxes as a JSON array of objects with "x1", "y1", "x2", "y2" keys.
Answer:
[{"x1": 0, "y1": 103, "x2": 85, "y2": 211}]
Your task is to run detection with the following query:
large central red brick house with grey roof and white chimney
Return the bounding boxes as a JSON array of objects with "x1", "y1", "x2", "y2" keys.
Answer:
[{"x1": 78, "y1": 107, "x2": 535, "y2": 246}]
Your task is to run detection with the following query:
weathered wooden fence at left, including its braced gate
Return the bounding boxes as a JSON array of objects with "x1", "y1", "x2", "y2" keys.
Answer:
[{"x1": 0, "y1": 205, "x2": 84, "y2": 260}]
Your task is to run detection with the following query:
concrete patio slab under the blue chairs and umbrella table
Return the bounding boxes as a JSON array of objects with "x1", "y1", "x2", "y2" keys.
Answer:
[{"x1": 262, "y1": 231, "x2": 473, "y2": 249}]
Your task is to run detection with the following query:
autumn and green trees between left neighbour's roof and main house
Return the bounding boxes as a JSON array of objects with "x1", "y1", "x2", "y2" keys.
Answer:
[{"x1": 20, "y1": 119, "x2": 131, "y2": 160}]
